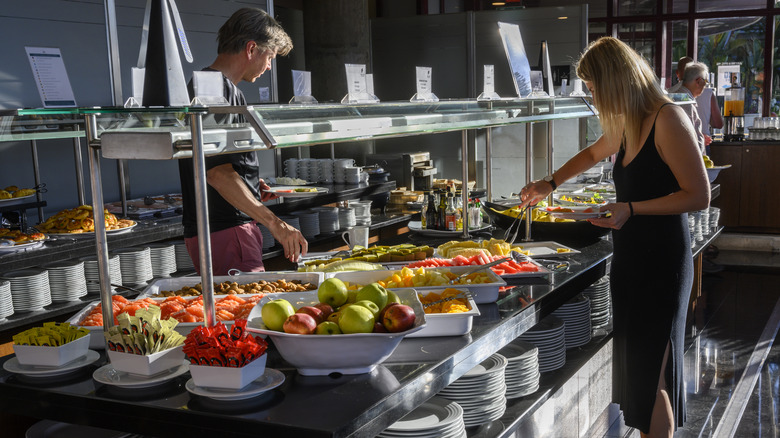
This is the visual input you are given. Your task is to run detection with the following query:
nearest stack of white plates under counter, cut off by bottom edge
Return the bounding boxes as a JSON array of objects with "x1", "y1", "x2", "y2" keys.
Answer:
[{"x1": 377, "y1": 397, "x2": 466, "y2": 438}]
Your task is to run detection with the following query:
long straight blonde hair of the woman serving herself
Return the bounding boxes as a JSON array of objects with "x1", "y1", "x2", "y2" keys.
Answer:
[{"x1": 577, "y1": 37, "x2": 671, "y2": 154}]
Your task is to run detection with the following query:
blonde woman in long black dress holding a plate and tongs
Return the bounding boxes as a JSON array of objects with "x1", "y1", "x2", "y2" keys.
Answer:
[{"x1": 520, "y1": 37, "x2": 710, "y2": 437}]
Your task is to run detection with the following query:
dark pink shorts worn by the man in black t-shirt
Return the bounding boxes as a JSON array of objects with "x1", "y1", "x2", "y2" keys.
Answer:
[{"x1": 184, "y1": 222, "x2": 265, "y2": 275}]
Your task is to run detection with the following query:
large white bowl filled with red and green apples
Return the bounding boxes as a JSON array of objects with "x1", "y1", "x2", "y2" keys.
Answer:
[{"x1": 247, "y1": 289, "x2": 426, "y2": 376}]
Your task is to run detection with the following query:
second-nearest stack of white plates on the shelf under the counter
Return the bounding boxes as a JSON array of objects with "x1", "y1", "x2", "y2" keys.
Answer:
[{"x1": 438, "y1": 354, "x2": 508, "y2": 427}]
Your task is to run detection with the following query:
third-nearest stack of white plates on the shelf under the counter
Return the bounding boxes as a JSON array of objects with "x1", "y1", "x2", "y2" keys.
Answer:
[{"x1": 498, "y1": 339, "x2": 541, "y2": 399}]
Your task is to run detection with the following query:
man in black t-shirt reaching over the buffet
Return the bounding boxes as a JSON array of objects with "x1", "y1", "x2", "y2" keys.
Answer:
[{"x1": 179, "y1": 8, "x2": 308, "y2": 275}]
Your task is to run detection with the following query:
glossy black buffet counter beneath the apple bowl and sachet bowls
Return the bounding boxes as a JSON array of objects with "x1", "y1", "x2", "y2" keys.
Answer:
[{"x1": 0, "y1": 240, "x2": 611, "y2": 437}]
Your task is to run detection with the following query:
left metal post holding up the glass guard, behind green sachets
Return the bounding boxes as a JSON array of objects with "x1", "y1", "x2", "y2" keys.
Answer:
[{"x1": 84, "y1": 114, "x2": 114, "y2": 332}]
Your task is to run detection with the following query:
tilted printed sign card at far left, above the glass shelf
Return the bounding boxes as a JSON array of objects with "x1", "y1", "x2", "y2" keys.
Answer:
[{"x1": 24, "y1": 47, "x2": 76, "y2": 108}]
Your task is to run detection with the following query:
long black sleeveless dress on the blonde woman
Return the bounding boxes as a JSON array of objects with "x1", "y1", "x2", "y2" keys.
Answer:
[{"x1": 610, "y1": 103, "x2": 693, "y2": 432}]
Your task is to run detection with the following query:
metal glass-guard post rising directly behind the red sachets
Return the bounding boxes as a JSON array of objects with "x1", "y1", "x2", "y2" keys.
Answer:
[{"x1": 190, "y1": 113, "x2": 217, "y2": 327}]
